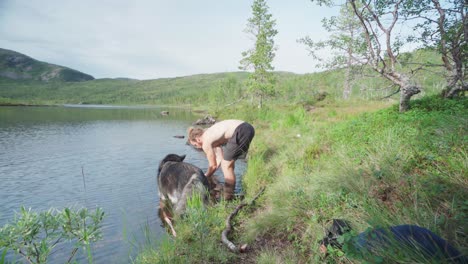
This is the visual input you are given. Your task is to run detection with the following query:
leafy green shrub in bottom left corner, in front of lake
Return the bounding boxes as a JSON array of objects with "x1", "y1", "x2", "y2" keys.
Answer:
[{"x1": 0, "y1": 207, "x2": 104, "y2": 263}]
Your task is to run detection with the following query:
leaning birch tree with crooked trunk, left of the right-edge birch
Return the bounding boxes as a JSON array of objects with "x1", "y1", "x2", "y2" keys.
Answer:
[{"x1": 312, "y1": 0, "x2": 421, "y2": 112}]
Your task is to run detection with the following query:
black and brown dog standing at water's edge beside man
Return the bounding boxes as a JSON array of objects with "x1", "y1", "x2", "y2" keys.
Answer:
[{"x1": 157, "y1": 154, "x2": 210, "y2": 236}]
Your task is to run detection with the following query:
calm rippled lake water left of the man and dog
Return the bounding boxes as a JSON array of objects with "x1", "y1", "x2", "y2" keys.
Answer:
[{"x1": 0, "y1": 106, "x2": 245, "y2": 263}]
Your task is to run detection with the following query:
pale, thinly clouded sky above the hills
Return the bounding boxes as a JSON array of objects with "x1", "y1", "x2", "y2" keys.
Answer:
[{"x1": 0, "y1": 0, "x2": 337, "y2": 79}]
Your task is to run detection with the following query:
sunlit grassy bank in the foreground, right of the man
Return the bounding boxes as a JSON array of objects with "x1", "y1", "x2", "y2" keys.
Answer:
[{"x1": 137, "y1": 97, "x2": 468, "y2": 263}]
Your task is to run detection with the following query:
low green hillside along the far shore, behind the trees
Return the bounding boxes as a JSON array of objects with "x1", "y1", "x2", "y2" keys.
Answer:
[{"x1": 0, "y1": 50, "x2": 444, "y2": 107}]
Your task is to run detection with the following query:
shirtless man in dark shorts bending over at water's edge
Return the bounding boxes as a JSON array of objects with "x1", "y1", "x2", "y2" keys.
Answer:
[{"x1": 188, "y1": 119, "x2": 255, "y2": 200}]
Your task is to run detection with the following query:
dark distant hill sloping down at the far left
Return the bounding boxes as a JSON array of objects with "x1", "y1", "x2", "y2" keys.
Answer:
[{"x1": 0, "y1": 48, "x2": 94, "y2": 82}]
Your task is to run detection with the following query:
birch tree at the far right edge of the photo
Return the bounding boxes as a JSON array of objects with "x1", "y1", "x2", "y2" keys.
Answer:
[{"x1": 404, "y1": 0, "x2": 468, "y2": 98}]
